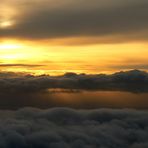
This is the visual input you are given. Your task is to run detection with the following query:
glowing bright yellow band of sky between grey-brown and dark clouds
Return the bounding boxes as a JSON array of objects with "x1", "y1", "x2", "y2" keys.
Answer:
[{"x1": 0, "y1": 39, "x2": 148, "y2": 74}]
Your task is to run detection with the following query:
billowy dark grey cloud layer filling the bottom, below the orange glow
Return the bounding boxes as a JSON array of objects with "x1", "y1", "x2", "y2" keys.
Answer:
[{"x1": 0, "y1": 108, "x2": 148, "y2": 148}]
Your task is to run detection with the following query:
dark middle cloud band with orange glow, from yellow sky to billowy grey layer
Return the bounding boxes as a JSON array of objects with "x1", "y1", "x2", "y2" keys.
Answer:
[{"x1": 0, "y1": 70, "x2": 148, "y2": 109}]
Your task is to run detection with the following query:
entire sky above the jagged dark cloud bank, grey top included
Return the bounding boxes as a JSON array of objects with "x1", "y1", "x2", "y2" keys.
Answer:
[{"x1": 0, "y1": 0, "x2": 148, "y2": 75}]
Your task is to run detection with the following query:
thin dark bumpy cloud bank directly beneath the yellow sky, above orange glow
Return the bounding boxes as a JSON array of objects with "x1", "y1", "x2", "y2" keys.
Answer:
[{"x1": 0, "y1": 70, "x2": 148, "y2": 93}]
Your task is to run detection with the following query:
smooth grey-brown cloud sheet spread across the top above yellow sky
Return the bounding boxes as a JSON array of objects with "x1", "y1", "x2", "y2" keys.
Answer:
[{"x1": 0, "y1": 0, "x2": 148, "y2": 41}]
